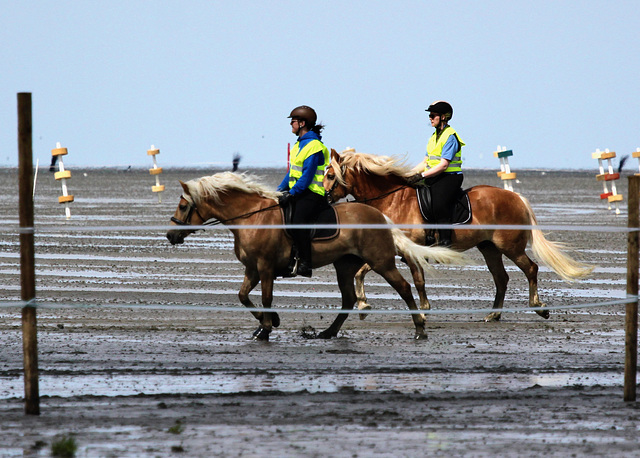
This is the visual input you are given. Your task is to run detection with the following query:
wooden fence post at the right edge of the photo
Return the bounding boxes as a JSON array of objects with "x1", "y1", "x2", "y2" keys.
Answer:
[{"x1": 624, "y1": 176, "x2": 640, "y2": 401}]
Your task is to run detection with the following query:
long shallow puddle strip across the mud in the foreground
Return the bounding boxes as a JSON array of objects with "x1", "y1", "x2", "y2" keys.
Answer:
[{"x1": 0, "y1": 372, "x2": 623, "y2": 399}]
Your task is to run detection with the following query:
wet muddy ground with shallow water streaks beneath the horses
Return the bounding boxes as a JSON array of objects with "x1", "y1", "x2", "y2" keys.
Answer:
[{"x1": 0, "y1": 170, "x2": 639, "y2": 456}]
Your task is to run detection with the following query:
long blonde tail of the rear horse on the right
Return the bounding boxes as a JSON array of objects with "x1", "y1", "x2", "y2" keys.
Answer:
[{"x1": 520, "y1": 192, "x2": 595, "y2": 282}]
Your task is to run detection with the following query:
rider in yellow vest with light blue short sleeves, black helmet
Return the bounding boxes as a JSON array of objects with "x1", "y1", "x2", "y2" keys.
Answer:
[{"x1": 409, "y1": 100, "x2": 464, "y2": 246}]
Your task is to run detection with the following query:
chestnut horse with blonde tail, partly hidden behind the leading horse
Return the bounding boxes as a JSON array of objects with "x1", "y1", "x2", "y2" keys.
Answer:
[{"x1": 324, "y1": 150, "x2": 593, "y2": 321}]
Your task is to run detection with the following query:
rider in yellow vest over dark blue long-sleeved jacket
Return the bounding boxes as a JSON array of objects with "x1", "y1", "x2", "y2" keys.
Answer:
[{"x1": 278, "y1": 105, "x2": 330, "y2": 277}]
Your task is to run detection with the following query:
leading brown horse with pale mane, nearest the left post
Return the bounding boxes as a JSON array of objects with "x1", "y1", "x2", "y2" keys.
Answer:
[{"x1": 167, "y1": 172, "x2": 464, "y2": 340}]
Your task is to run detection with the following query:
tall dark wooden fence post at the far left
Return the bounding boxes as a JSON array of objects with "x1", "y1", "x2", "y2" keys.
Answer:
[{"x1": 18, "y1": 92, "x2": 40, "y2": 415}]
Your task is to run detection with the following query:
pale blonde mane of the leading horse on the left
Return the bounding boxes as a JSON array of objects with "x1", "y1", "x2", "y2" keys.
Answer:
[{"x1": 185, "y1": 172, "x2": 280, "y2": 205}]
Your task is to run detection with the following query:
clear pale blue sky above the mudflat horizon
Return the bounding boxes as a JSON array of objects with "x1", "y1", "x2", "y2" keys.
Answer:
[{"x1": 0, "y1": 0, "x2": 640, "y2": 172}]
